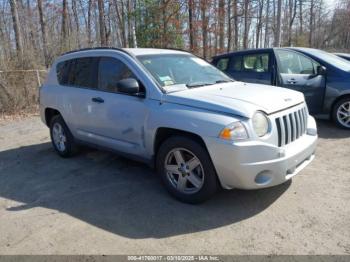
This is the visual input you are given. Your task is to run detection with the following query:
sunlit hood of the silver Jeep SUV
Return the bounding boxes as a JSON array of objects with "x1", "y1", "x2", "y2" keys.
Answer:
[{"x1": 162, "y1": 82, "x2": 304, "y2": 118}]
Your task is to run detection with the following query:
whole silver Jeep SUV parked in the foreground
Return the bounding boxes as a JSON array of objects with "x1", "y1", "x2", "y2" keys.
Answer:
[{"x1": 40, "y1": 48, "x2": 317, "y2": 203}]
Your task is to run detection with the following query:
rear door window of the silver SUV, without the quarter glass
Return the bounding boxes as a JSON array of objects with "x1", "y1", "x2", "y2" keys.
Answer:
[{"x1": 68, "y1": 57, "x2": 98, "y2": 88}]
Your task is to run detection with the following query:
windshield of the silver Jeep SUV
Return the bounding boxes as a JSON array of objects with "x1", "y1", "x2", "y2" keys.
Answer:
[{"x1": 137, "y1": 54, "x2": 232, "y2": 90}]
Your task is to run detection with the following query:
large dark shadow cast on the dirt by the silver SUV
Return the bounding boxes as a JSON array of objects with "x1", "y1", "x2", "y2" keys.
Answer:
[{"x1": 0, "y1": 143, "x2": 290, "y2": 238}]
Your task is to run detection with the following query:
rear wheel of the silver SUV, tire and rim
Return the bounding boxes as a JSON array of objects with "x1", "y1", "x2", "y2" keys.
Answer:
[{"x1": 50, "y1": 115, "x2": 77, "y2": 158}]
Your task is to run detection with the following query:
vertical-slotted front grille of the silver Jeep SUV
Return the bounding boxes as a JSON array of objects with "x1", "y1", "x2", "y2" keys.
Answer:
[{"x1": 276, "y1": 107, "x2": 308, "y2": 146}]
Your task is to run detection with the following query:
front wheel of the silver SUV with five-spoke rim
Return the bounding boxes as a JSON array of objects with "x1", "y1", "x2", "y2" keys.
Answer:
[{"x1": 156, "y1": 136, "x2": 218, "y2": 204}]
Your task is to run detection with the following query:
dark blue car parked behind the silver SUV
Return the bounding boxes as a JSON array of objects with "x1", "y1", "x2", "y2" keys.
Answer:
[{"x1": 212, "y1": 48, "x2": 350, "y2": 129}]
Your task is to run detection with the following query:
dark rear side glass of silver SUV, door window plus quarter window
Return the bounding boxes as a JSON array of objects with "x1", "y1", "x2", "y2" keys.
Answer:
[{"x1": 56, "y1": 57, "x2": 98, "y2": 88}]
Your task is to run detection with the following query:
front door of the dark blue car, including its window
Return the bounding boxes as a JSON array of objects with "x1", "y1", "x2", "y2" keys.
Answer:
[{"x1": 275, "y1": 50, "x2": 326, "y2": 114}]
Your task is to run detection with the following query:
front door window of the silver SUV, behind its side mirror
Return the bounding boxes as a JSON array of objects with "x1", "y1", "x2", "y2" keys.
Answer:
[{"x1": 98, "y1": 57, "x2": 136, "y2": 93}]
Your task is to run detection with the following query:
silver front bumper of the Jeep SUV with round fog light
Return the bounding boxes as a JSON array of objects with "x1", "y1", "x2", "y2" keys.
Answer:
[{"x1": 206, "y1": 118, "x2": 317, "y2": 189}]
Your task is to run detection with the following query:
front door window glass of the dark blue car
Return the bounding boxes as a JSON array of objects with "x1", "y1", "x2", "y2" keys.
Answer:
[{"x1": 276, "y1": 50, "x2": 319, "y2": 75}]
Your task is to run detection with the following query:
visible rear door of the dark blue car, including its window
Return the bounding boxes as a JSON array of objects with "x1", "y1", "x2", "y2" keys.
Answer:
[{"x1": 227, "y1": 52, "x2": 273, "y2": 85}]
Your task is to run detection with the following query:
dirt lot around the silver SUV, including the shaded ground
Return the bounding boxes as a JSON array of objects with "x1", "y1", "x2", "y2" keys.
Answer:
[{"x1": 0, "y1": 117, "x2": 350, "y2": 254}]
